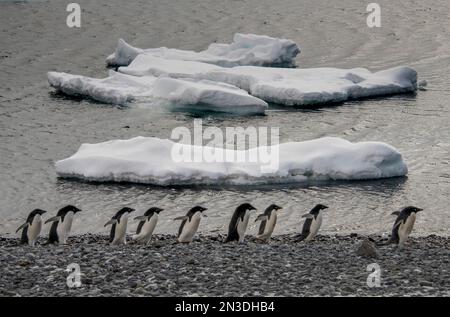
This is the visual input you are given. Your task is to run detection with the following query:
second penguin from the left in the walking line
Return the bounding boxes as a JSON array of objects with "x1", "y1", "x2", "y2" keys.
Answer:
[{"x1": 45, "y1": 205, "x2": 81, "y2": 244}]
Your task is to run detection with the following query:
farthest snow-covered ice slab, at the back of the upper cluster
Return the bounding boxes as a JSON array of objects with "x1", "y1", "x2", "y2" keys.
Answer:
[{"x1": 106, "y1": 33, "x2": 300, "y2": 67}]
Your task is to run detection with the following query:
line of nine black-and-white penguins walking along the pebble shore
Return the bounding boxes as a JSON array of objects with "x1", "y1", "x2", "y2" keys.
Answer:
[{"x1": 16, "y1": 203, "x2": 422, "y2": 248}]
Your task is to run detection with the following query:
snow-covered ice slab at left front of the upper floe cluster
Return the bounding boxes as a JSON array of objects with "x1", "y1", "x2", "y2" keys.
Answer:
[{"x1": 47, "y1": 71, "x2": 267, "y2": 114}]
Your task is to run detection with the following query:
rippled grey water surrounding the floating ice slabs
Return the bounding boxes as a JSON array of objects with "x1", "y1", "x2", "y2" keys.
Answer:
[{"x1": 0, "y1": 0, "x2": 450, "y2": 236}]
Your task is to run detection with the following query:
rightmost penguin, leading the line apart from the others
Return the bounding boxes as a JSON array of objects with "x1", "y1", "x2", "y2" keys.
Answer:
[{"x1": 388, "y1": 206, "x2": 423, "y2": 249}]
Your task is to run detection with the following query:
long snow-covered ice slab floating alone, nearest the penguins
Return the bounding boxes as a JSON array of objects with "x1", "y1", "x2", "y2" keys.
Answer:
[{"x1": 56, "y1": 137, "x2": 407, "y2": 185}]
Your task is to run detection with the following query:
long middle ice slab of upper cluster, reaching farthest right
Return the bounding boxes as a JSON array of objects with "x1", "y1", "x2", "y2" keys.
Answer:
[{"x1": 118, "y1": 54, "x2": 417, "y2": 106}]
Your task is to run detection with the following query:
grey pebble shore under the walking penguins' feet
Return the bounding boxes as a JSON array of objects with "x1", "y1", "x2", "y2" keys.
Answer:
[{"x1": 0, "y1": 234, "x2": 450, "y2": 296}]
